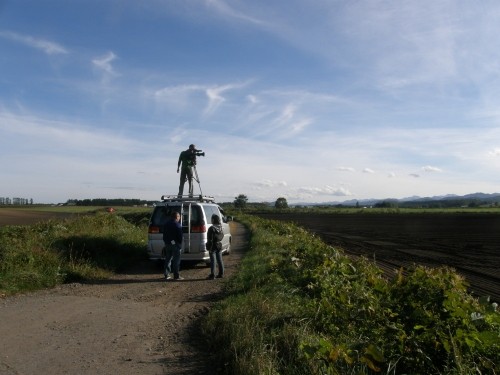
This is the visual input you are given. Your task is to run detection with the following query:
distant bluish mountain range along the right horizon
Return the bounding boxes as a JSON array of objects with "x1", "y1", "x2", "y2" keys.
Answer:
[{"x1": 318, "y1": 193, "x2": 500, "y2": 207}]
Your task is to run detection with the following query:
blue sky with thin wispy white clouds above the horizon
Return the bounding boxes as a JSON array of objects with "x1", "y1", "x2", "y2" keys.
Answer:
[{"x1": 0, "y1": 0, "x2": 500, "y2": 203}]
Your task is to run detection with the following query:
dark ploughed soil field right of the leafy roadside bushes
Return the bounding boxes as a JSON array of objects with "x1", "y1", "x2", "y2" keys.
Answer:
[{"x1": 259, "y1": 213, "x2": 500, "y2": 301}]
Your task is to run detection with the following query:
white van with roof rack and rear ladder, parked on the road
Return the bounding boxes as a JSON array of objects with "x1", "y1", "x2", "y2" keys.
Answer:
[{"x1": 148, "y1": 195, "x2": 231, "y2": 264}]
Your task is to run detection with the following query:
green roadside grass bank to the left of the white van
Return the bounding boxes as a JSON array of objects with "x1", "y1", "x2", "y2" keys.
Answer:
[{"x1": 0, "y1": 212, "x2": 147, "y2": 295}]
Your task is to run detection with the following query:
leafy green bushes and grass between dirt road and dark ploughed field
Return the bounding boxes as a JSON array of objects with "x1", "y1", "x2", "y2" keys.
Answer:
[{"x1": 202, "y1": 215, "x2": 500, "y2": 375}]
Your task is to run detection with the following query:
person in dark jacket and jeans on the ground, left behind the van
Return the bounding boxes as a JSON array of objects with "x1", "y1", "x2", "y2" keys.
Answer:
[{"x1": 163, "y1": 211, "x2": 183, "y2": 280}]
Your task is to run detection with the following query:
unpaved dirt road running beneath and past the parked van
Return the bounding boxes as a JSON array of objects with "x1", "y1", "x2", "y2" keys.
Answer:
[{"x1": 0, "y1": 222, "x2": 247, "y2": 375}]
